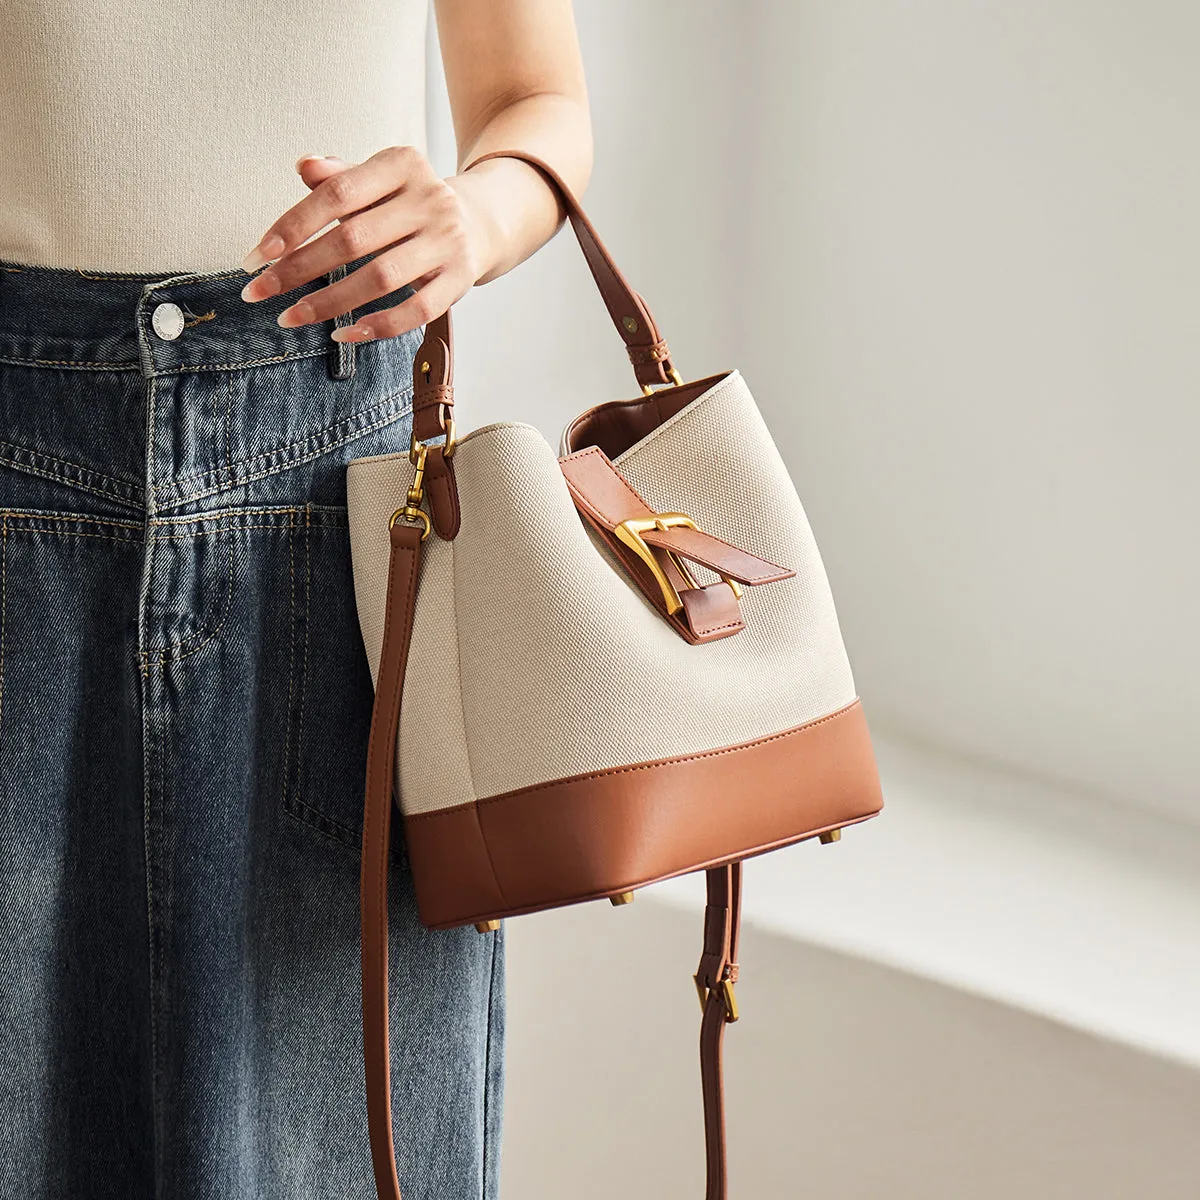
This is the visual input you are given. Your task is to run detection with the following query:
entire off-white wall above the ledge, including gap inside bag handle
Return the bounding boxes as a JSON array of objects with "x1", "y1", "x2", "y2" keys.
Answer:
[{"x1": 431, "y1": 0, "x2": 1200, "y2": 820}]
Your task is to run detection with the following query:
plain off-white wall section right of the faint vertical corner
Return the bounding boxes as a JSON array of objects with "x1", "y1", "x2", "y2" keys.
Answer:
[{"x1": 746, "y1": 0, "x2": 1200, "y2": 818}]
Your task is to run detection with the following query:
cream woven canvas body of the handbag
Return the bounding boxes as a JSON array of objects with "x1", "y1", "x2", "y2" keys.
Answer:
[{"x1": 347, "y1": 370, "x2": 856, "y2": 814}]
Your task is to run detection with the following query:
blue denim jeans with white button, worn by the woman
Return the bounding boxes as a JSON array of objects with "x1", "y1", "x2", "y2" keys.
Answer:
[{"x1": 0, "y1": 260, "x2": 504, "y2": 1200}]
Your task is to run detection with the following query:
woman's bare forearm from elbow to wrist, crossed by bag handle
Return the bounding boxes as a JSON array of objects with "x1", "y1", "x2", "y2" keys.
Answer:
[{"x1": 446, "y1": 92, "x2": 593, "y2": 284}]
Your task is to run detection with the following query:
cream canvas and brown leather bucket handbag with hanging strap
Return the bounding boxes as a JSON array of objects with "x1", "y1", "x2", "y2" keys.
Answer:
[{"x1": 347, "y1": 150, "x2": 883, "y2": 1200}]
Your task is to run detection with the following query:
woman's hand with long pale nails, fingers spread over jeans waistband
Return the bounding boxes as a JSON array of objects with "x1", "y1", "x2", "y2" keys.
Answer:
[{"x1": 241, "y1": 146, "x2": 498, "y2": 342}]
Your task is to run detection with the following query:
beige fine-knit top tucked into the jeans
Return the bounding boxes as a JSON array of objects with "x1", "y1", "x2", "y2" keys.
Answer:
[{"x1": 0, "y1": 0, "x2": 428, "y2": 272}]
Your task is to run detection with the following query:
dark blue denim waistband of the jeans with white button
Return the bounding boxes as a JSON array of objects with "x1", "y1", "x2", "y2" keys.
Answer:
[{"x1": 0, "y1": 254, "x2": 415, "y2": 378}]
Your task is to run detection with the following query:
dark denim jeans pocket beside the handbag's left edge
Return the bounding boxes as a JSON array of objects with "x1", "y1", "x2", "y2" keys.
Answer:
[{"x1": 283, "y1": 506, "x2": 408, "y2": 865}]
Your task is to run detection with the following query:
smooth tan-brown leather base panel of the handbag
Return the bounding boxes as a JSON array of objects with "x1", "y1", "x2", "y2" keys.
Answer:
[{"x1": 404, "y1": 701, "x2": 883, "y2": 929}]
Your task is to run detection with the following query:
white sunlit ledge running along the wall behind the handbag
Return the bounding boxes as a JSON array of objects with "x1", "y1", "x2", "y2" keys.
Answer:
[{"x1": 652, "y1": 733, "x2": 1200, "y2": 1067}]
